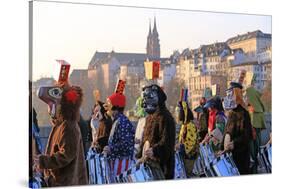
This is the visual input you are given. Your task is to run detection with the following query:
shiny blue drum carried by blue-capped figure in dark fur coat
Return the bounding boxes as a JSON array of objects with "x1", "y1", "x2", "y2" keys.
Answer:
[{"x1": 206, "y1": 153, "x2": 240, "y2": 177}]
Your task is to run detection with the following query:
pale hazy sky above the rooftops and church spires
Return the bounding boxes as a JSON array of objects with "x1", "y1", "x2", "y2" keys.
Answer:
[{"x1": 32, "y1": 2, "x2": 271, "y2": 80}]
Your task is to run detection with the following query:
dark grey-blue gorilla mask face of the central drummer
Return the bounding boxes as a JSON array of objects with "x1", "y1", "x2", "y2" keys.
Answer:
[{"x1": 143, "y1": 86, "x2": 159, "y2": 114}]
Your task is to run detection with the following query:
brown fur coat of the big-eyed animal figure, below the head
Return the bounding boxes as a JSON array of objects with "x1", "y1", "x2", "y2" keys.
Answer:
[{"x1": 39, "y1": 121, "x2": 88, "y2": 186}]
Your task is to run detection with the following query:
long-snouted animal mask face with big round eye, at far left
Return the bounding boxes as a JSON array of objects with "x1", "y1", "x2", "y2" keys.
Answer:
[{"x1": 37, "y1": 86, "x2": 62, "y2": 119}]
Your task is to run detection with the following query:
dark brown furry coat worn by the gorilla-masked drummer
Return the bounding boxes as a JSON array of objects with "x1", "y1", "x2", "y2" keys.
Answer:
[{"x1": 137, "y1": 107, "x2": 176, "y2": 179}]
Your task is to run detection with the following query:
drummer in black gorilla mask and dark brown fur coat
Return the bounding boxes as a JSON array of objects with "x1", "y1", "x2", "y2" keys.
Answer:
[{"x1": 136, "y1": 85, "x2": 175, "y2": 179}]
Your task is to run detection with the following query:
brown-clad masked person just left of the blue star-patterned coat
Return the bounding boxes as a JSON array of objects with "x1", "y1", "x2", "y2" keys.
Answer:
[{"x1": 91, "y1": 101, "x2": 112, "y2": 153}]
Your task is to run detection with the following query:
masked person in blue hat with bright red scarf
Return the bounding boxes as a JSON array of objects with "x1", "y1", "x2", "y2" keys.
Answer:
[{"x1": 201, "y1": 96, "x2": 227, "y2": 143}]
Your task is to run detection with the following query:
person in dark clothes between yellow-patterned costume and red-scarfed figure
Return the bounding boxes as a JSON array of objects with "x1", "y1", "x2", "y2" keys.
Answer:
[{"x1": 194, "y1": 97, "x2": 209, "y2": 142}]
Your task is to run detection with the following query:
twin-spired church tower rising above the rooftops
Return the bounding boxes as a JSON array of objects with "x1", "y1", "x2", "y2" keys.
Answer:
[{"x1": 146, "y1": 17, "x2": 160, "y2": 59}]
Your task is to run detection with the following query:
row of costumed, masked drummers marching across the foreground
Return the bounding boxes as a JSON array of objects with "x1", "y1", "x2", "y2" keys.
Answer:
[{"x1": 30, "y1": 67, "x2": 271, "y2": 187}]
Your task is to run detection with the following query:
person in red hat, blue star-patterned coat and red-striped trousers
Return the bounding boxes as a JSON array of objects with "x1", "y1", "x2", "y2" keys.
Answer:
[{"x1": 103, "y1": 80, "x2": 135, "y2": 182}]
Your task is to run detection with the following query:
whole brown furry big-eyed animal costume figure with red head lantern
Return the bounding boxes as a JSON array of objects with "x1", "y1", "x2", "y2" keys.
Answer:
[{"x1": 34, "y1": 60, "x2": 88, "y2": 187}]
